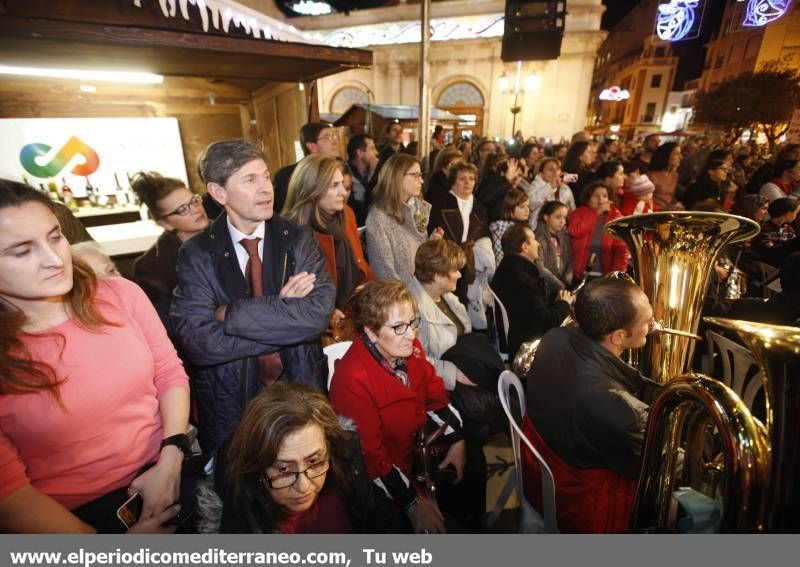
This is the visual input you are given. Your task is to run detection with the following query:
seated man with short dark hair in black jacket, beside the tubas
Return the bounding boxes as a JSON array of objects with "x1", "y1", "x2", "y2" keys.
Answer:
[{"x1": 526, "y1": 278, "x2": 657, "y2": 479}]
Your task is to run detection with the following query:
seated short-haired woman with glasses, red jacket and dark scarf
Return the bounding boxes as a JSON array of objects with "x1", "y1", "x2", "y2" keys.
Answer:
[{"x1": 330, "y1": 279, "x2": 486, "y2": 533}]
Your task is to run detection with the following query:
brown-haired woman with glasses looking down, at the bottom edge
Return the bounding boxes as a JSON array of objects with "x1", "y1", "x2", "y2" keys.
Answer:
[{"x1": 216, "y1": 382, "x2": 405, "y2": 534}]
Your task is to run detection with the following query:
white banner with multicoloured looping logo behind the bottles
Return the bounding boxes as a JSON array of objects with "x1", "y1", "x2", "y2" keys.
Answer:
[{"x1": 0, "y1": 118, "x2": 188, "y2": 197}]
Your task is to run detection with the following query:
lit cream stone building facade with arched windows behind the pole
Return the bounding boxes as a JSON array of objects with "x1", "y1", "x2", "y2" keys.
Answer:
[{"x1": 256, "y1": 0, "x2": 606, "y2": 140}]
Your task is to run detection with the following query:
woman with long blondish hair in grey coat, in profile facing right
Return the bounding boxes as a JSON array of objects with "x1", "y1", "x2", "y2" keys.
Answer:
[{"x1": 366, "y1": 154, "x2": 443, "y2": 282}]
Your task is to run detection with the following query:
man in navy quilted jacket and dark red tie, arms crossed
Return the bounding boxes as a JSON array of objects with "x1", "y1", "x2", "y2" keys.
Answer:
[{"x1": 170, "y1": 140, "x2": 335, "y2": 450}]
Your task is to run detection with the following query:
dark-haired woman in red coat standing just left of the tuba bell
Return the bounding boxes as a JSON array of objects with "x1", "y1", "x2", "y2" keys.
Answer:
[{"x1": 568, "y1": 181, "x2": 630, "y2": 281}]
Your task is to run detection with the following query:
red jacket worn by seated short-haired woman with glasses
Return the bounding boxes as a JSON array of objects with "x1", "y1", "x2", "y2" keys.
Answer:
[{"x1": 330, "y1": 335, "x2": 450, "y2": 479}]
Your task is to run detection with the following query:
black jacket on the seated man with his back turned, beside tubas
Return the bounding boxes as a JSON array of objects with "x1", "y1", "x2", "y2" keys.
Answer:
[{"x1": 526, "y1": 327, "x2": 659, "y2": 478}]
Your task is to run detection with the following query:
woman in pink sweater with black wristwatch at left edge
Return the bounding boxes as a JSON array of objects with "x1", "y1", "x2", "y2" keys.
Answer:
[{"x1": 0, "y1": 180, "x2": 189, "y2": 533}]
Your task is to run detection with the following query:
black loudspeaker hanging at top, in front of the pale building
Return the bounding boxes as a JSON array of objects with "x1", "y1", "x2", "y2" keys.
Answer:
[{"x1": 501, "y1": 0, "x2": 567, "y2": 61}]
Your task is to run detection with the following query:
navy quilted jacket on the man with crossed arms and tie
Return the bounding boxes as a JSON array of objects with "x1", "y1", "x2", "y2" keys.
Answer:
[{"x1": 170, "y1": 214, "x2": 335, "y2": 451}]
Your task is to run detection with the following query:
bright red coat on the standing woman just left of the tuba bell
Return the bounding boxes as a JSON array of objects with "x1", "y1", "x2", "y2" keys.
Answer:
[{"x1": 568, "y1": 205, "x2": 630, "y2": 281}]
